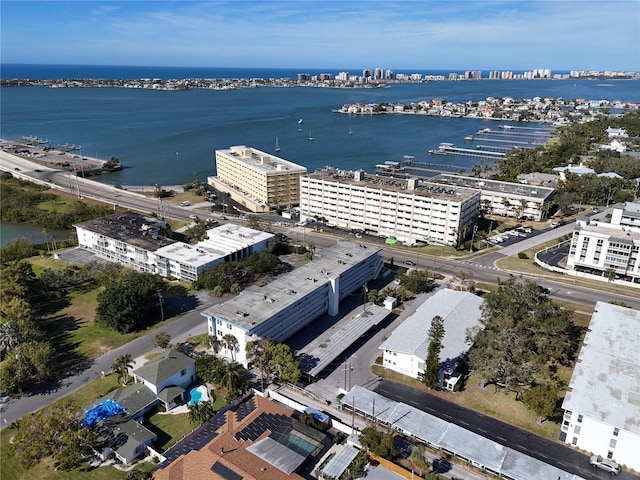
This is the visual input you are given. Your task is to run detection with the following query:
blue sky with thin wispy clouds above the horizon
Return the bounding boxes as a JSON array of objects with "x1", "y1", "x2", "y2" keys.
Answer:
[{"x1": 0, "y1": 0, "x2": 640, "y2": 71}]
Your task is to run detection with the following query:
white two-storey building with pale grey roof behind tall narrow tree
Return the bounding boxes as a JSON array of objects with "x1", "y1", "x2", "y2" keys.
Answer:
[{"x1": 380, "y1": 288, "x2": 482, "y2": 390}]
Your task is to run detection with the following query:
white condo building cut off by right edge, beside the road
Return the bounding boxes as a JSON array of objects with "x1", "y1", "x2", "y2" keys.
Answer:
[{"x1": 567, "y1": 202, "x2": 640, "y2": 283}]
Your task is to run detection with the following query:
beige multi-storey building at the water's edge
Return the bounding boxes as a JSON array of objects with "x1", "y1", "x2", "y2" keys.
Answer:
[{"x1": 207, "y1": 145, "x2": 307, "y2": 212}]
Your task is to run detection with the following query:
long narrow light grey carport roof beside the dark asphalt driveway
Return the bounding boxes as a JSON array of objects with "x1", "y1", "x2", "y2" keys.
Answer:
[{"x1": 341, "y1": 385, "x2": 584, "y2": 480}]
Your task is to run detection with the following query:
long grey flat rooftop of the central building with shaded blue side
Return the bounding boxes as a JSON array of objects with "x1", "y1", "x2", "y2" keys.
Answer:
[{"x1": 202, "y1": 240, "x2": 381, "y2": 331}]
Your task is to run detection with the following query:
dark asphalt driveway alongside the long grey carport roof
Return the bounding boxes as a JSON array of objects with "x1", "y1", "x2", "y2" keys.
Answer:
[{"x1": 374, "y1": 380, "x2": 638, "y2": 480}]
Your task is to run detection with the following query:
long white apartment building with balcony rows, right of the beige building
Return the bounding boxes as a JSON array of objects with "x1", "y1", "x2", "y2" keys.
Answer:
[{"x1": 300, "y1": 167, "x2": 480, "y2": 245}]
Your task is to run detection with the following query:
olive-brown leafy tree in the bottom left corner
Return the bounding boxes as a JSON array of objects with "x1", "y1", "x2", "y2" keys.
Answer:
[{"x1": 9, "y1": 399, "x2": 95, "y2": 470}]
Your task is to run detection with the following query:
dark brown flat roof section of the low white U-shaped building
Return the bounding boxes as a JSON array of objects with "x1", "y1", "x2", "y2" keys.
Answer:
[{"x1": 75, "y1": 212, "x2": 176, "y2": 252}]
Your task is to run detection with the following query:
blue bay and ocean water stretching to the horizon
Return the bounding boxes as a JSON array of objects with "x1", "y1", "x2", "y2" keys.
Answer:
[{"x1": 0, "y1": 65, "x2": 640, "y2": 185}]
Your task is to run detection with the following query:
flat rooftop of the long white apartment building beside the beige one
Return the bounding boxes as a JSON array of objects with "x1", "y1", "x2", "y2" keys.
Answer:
[{"x1": 307, "y1": 167, "x2": 478, "y2": 202}]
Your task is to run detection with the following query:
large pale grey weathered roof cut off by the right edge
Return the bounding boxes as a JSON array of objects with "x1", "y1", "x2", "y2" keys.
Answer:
[{"x1": 562, "y1": 302, "x2": 640, "y2": 435}]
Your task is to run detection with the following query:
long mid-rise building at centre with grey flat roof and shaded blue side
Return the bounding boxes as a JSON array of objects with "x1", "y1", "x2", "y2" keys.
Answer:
[{"x1": 201, "y1": 241, "x2": 383, "y2": 366}]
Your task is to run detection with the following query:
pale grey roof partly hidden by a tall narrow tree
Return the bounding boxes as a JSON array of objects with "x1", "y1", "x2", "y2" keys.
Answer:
[{"x1": 380, "y1": 288, "x2": 483, "y2": 362}]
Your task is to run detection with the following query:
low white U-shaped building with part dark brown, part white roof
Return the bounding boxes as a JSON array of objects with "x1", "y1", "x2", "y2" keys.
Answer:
[{"x1": 75, "y1": 212, "x2": 274, "y2": 281}]
